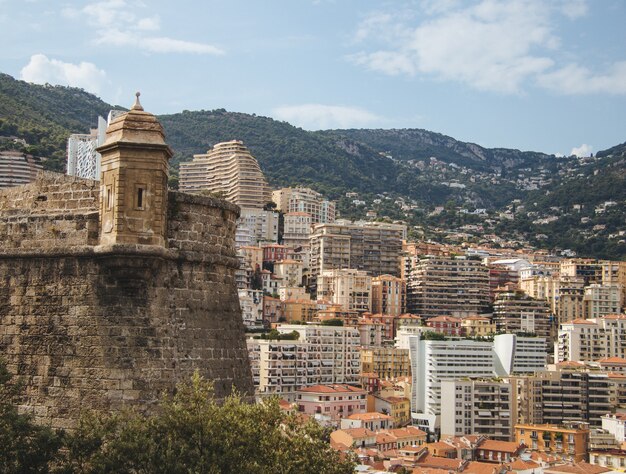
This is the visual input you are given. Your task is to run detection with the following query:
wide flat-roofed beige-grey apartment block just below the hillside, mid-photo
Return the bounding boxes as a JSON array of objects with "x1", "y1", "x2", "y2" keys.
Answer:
[{"x1": 311, "y1": 222, "x2": 406, "y2": 286}]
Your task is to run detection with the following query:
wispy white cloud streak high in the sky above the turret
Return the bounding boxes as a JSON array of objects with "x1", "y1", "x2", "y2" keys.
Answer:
[{"x1": 62, "y1": 0, "x2": 224, "y2": 55}]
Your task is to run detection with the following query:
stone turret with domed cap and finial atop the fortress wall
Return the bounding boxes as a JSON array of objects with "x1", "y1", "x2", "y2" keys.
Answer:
[{"x1": 97, "y1": 92, "x2": 172, "y2": 247}]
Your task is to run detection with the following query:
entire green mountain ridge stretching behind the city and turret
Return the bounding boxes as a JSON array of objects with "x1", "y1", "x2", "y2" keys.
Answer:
[{"x1": 0, "y1": 73, "x2": 626, "y2": 259}]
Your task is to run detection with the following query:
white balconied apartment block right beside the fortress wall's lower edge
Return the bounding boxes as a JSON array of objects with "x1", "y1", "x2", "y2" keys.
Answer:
[{"x1": 247, "y1": 324, "x2": 358, "y2": 403}]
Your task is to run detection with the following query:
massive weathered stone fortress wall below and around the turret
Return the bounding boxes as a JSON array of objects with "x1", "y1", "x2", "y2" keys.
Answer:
[{"x1": 0, "y1": 98, "x2": 253, "y2": 428}]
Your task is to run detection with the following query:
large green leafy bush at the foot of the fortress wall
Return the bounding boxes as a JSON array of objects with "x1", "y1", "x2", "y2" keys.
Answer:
[{"x1": 64, "y1": 375, "x2": 354, "y2": 474}]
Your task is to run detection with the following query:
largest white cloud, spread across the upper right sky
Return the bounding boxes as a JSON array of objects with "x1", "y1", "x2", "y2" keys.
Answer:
[{"x1": 348, "y1": 0, "x2": 626, "y2": 94}]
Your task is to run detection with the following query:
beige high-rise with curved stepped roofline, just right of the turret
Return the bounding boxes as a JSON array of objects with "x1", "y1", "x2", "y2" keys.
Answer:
[{"x1": 179, "y1": 140, "x2": 272, "y2": 209}]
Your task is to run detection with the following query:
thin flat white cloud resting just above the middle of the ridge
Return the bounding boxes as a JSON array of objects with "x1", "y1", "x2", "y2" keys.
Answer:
[{"x1": 273, "y1": 104, "x2": 382, "y2": 130}]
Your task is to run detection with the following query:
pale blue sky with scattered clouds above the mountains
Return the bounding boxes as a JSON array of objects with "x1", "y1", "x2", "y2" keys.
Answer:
[{"x1": 0, "y1": 0, "x2": 626, "y2": 156}]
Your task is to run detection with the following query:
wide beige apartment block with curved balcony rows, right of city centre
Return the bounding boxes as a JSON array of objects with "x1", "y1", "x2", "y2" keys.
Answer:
[{"x1": 405, "y1": 256, "x2": 490, "y2": 319}]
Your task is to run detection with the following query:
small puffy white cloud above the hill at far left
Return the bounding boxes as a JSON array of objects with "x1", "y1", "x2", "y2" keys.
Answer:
[{"x1": 20, "y1": 54, "x2": 107, "y2": 94}]
